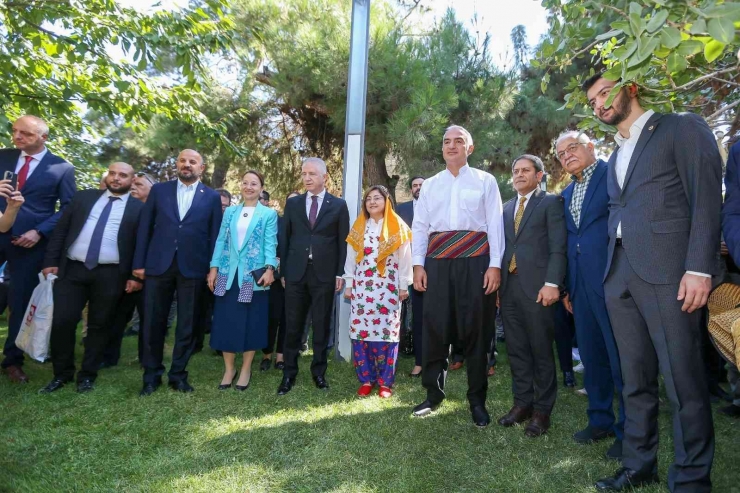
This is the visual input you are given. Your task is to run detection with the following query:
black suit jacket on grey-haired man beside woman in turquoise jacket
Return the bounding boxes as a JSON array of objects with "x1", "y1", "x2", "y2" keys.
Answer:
[{"x1": 278, "y1": 192, "x2": 349, "y2": 282}]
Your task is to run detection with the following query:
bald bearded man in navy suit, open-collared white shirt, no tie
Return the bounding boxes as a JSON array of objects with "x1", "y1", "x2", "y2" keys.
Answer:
[{"x1": 133, "y1": 149, "x2": 223, "y2": 396}]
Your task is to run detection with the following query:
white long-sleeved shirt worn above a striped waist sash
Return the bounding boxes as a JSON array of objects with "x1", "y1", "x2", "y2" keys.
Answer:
[{"x1": 412, "y1": 164, "x2": 505, "y2": 268}]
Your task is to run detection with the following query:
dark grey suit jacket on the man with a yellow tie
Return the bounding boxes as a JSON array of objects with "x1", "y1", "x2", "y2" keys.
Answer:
[{"x1": 501, "y1": 188, "x2": 568, "y2": 301}]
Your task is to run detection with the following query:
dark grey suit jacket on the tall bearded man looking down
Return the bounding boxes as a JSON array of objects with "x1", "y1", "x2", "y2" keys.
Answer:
[{"x1": 604, "y1": 113, "x2": 722, "y2": 284}]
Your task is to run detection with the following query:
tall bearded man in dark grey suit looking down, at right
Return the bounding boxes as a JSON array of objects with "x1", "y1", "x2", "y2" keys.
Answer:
[{"x1": 584, "y1": 74, "x2": 722, "y2": 492}]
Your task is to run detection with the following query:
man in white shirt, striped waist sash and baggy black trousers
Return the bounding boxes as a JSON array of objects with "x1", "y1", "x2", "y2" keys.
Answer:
[{"x1": 412, "y1": 126, "x2": 504, "y2": 427}]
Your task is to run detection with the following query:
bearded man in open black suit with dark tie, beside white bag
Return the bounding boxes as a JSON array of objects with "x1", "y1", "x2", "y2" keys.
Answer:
[{"x1": 41, "y1": 163, "x2": 144, "y2": 393}]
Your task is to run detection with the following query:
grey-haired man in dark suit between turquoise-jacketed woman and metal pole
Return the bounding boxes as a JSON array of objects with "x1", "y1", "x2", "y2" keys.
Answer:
[{"x1": 278, "y1": 158, "x2": 349, "y2": 395}]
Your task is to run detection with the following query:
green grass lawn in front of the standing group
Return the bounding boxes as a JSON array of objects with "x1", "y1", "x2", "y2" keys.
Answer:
[{"x1": 0, "y1": 320, "x2": 740, "y2": 493}]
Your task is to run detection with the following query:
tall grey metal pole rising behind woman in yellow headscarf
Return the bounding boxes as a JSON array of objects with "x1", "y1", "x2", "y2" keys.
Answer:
[{"x1": 335, "y1": 0, "x2": 370, "y2": 361}]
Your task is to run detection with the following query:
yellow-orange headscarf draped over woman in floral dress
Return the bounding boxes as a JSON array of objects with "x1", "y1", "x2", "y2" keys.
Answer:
[{"x1": 347, "y1": 194, "x2": 411, "y2": 277}]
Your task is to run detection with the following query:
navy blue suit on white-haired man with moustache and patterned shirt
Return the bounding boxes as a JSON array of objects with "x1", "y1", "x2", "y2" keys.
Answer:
[{"x1": 562, "y1": 160, "x2": 624, "y2": 440}]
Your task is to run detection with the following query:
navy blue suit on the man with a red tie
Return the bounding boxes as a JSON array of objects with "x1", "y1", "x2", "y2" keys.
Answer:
[{"x1": 0, "y1": 149, "x2": 76, "y2": 368}]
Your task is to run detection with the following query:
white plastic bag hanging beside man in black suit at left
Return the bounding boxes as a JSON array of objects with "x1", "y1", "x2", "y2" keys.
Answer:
[{"x1": 15, "y1": 272, "x2": 57, "y2": 363}]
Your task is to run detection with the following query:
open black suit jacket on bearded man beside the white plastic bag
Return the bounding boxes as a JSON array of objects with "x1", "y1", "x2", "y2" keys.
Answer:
[{"x1": 44, "y1": 190, "x2": 144, "y2": 278}]
